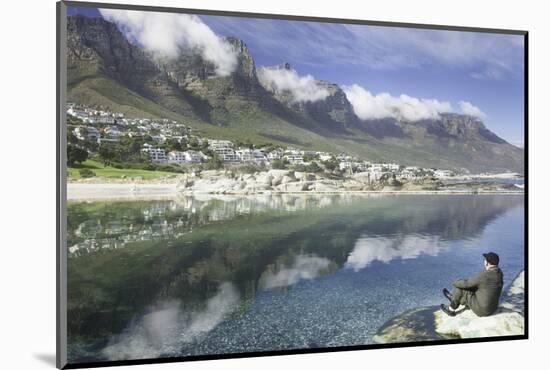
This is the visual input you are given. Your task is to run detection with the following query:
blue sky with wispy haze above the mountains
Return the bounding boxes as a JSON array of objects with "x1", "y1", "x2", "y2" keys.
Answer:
[{"x1": 69, "y1": 8, "x2": 524, "y2": 144}]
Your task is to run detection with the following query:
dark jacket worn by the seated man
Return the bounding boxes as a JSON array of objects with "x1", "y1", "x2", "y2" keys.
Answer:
[{"x1": 453, "y1": 267, "x2": 503, "y2": 316}]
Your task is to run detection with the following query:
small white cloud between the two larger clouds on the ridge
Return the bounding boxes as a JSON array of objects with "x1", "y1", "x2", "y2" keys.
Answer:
[{"x1": 258, "y1": 67, "x2": 329, "y2": 102}]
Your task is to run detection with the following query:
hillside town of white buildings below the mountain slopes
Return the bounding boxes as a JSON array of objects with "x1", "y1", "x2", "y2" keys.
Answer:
[{"x1": 67, "y1": 103, "x2": 462, "y2": 181}]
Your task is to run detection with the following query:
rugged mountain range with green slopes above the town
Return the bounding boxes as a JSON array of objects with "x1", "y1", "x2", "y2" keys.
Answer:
[{"x1": 67, "y1": 15, "x2": 524, "y2": 173}]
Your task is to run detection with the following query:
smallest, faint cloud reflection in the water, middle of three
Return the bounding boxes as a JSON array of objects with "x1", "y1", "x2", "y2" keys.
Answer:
[{"x1": 260, "y1": 255, "x2": 330, "y2": 289}]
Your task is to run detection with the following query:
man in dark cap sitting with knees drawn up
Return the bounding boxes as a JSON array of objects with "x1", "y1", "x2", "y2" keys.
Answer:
[{"x1": 441, "y1": 252, "x2": 503, "y2": 316}]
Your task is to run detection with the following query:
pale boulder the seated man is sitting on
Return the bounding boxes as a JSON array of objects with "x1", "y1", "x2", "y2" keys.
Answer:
[{"x1": 373, "y1": 272, "x2": 525, "y2": 343}]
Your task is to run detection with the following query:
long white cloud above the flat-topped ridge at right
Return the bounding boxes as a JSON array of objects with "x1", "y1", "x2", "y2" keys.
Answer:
[{"x1": 344, "y1": 84, "x2": 453, "y2": 121}]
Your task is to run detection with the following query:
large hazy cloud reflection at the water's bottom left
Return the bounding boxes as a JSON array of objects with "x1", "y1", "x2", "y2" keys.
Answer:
[{"x1": 103, "y1": 282, "x2": 240, "y2": 361}]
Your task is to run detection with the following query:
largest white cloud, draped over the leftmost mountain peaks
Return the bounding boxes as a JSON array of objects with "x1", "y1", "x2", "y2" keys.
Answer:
[{"x1": 99, "y1": 9, "x2": 237, "y2": 76}]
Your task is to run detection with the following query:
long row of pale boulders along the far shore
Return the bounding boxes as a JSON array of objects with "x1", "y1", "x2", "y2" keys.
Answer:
[{"x1": 178, "y1": 169, "x2": 437, "y2": 194}]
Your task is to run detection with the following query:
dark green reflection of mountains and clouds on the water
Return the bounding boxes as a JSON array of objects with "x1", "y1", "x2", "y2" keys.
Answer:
[{"x1": 68, "y1": 195, "x2": 523, "y2": 361}]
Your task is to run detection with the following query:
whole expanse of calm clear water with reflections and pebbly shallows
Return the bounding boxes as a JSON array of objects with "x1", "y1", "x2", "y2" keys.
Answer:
[{"x1": 68, "y1": 195, "x2": 524, "y2": 362}]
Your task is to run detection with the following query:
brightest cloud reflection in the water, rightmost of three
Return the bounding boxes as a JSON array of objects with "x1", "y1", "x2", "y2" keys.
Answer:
[{"x1": 346, "y1": 235, "x2": 443, "y2": 271}]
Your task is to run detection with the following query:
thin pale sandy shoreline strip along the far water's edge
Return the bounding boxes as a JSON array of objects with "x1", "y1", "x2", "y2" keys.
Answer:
[{"x1": 67, "y1": 181, "x2": 525, "y2": 201}]
